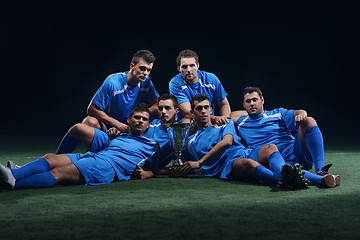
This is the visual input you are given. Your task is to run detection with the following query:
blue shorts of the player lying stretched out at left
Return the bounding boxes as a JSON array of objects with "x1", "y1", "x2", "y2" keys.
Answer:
[{"x1": 66, "y1": 152, "x2": 115, "y2": 185}]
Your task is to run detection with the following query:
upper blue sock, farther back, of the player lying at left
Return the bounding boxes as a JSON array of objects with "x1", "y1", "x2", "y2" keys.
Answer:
[{"x1": 11, "y1": 158, "x2": 50, "y2": 180}]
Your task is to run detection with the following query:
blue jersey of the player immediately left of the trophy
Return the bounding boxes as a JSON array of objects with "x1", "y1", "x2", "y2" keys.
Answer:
[{"x1": 143, "y1": 119, "x2": 175, "y2": 168}]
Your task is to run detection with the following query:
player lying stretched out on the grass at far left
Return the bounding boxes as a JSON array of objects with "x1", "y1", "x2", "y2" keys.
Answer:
[{"x1": 0, "y1": 104, "x2": 158, "y2": 190}]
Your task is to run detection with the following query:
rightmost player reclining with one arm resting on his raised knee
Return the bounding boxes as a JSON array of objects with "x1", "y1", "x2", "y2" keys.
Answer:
[{"x1": 231, "y1": 87, "x2": 340, "y2": 187}]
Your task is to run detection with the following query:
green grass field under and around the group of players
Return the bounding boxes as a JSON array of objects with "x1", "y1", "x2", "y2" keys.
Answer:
[{"x1": 0, "y1": 135, "x2": 360, "y2": 240}]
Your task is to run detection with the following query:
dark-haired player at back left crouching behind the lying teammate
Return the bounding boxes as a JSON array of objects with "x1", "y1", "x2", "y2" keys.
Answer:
[{"x1": 55, "y1": 50, "x2": 159, "y2": 154}]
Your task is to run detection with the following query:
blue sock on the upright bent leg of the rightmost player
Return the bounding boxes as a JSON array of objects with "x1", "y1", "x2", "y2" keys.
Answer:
[{"x1": 305, "y1": 126, "x2": 325, "y2": 172}]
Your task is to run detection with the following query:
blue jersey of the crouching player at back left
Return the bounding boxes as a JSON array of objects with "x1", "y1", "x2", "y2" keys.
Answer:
[{"x1": 91, "y1": 71, "x2": 159, "y2": 127}]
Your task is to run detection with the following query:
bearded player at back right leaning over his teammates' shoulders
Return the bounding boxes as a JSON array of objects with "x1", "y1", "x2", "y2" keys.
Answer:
[{"x1": 169, "y1": 49, "x2": 231, "y2": 124}]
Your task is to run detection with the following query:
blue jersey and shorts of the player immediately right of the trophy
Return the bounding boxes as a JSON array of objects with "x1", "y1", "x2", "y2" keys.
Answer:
[{"x1": 183, "y1": 119, "x2": 247, "y2": 179}]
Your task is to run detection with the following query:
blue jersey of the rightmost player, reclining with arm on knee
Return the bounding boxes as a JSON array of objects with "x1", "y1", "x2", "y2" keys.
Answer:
[{"x1": 236, "y1": 108, "x2": 296, "y2": 152}]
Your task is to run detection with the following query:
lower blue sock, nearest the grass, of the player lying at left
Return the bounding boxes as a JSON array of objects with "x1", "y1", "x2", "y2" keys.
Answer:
[{"x1": 14, "y1": 172, "x2": 56, "y2": 189}]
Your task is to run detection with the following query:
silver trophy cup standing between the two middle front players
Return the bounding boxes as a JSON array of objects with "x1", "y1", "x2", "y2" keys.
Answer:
[{"x1": 168, "y1": 123, "x2": 190, "y2": 177}]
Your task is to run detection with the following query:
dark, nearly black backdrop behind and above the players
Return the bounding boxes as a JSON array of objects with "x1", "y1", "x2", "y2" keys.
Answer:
[{"x1": 0, "y1": 2, "x2": 360, "y2": 146}]
